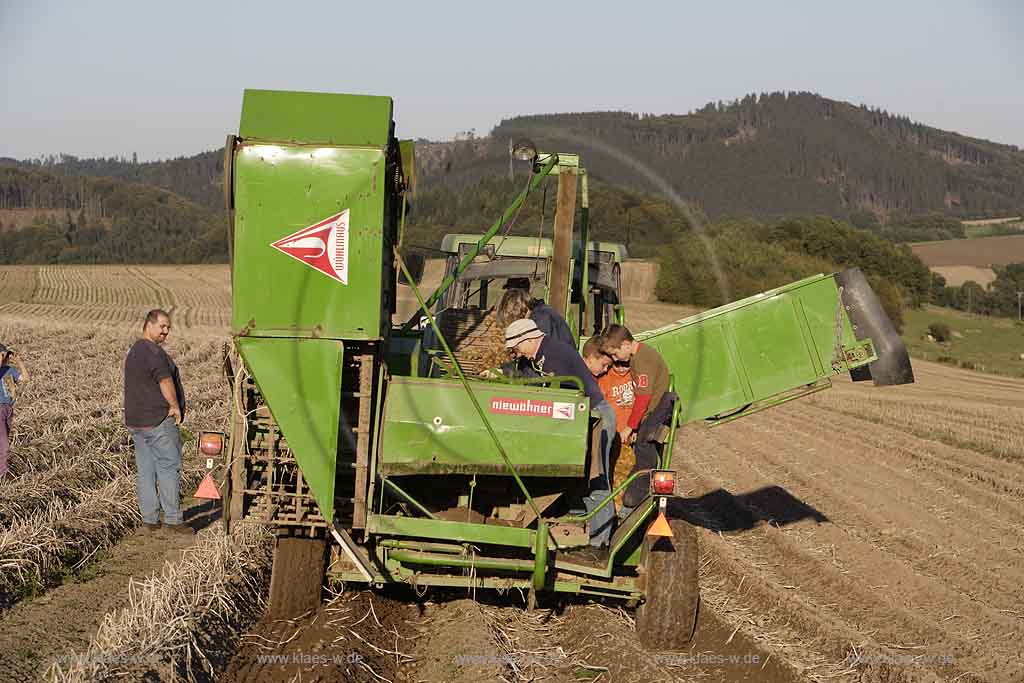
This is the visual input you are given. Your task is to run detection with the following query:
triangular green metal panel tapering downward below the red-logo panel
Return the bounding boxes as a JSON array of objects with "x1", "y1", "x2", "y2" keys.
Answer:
[{"x1": 237, "y1": 337, "x2": 343, "y2": 520}]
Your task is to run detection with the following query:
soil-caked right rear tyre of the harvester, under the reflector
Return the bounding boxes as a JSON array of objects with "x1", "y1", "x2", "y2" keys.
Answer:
[{"x1": 637, "y1": 519, "x2": 700, "y2": 652}]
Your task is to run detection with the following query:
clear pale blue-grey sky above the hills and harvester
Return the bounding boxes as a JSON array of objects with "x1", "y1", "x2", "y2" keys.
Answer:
[{"x1": 0, "y1": 0, "x2": 1024, "y2": 159}]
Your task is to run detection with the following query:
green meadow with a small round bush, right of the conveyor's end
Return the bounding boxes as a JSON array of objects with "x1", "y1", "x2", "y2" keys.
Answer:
[{"x1": 903, "y1": 306, "x2": 1024, "y2": 377}]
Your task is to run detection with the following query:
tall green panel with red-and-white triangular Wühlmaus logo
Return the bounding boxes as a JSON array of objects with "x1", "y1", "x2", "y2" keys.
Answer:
[{"x1": 231, "y1": 142, "x2": 388, "y2": 339}]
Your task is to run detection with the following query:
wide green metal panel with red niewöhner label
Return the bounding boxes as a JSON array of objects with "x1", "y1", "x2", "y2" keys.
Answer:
[{"x1": 380, "y1": 377, "x2": 590, "y2": 476}]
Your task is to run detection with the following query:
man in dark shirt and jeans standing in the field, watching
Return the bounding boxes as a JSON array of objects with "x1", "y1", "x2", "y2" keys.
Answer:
[{"x1": 125, "y1": 309, "x2": 194, "y2": 535}]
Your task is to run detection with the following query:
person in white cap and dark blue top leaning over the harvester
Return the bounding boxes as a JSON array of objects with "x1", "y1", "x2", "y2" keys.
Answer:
[{"x1": 505, "y1": 317, "x2": 615, "y2": 548}]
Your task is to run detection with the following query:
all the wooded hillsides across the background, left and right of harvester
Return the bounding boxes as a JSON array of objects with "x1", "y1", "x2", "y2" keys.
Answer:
[{"x1": 9, "y1": 93, "x2": 1024, "y2": 317}]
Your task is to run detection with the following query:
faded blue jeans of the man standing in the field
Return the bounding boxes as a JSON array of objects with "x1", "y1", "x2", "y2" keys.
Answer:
[{"x1": 128, "y1": 416, "x2": 181, "y2": 524}]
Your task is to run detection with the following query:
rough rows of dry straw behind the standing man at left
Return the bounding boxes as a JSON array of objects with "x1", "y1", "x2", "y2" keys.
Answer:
[{"x1": 0, "y1": 321, "x2": 227, "y2": 604}]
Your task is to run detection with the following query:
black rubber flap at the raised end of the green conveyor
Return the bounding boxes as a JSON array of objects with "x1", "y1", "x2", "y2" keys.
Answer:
[{"x1": 835, "y1": 268, "x2": 913, "y2": 386}]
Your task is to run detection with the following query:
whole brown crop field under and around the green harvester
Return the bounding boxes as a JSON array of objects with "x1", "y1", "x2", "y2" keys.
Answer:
[{"x1": 0, "y1": 266, "x2": 1024, "y2": 683}]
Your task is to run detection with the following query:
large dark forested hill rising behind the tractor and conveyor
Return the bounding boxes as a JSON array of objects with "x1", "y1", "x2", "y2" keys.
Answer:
[{"x1": 417, "y1": 93, "x2": 1024, "y2": 222}]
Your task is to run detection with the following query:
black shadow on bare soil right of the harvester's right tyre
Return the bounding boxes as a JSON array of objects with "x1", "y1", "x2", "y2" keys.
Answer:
[{"x1": 669, "y1": 486, "x2": 828, "y2": 532}]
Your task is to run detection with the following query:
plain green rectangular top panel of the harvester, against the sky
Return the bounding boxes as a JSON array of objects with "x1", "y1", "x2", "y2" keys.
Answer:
[{"x1": 239, "y1": 90, "x2": 391, "y2": 148}]
